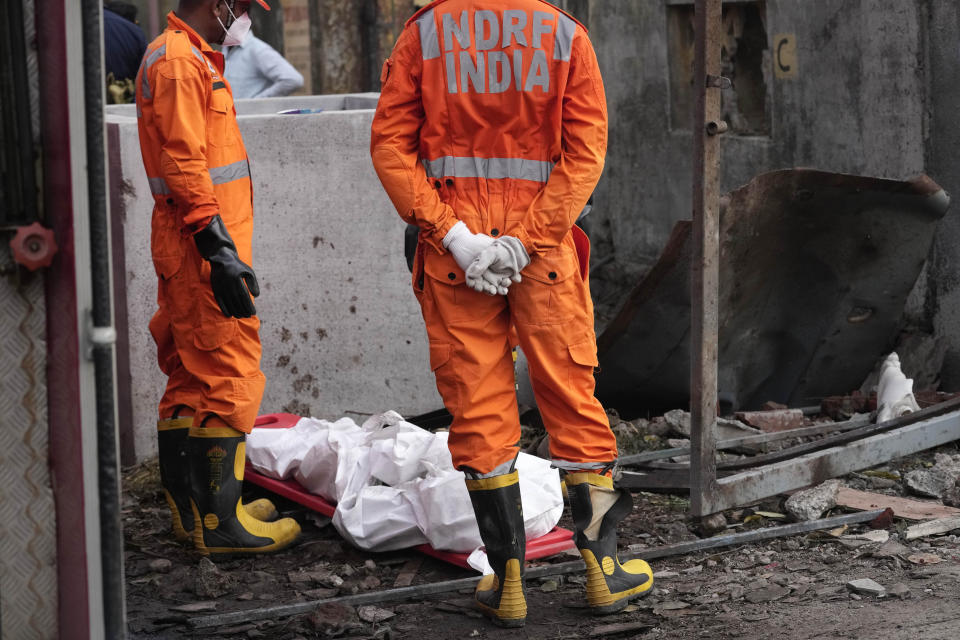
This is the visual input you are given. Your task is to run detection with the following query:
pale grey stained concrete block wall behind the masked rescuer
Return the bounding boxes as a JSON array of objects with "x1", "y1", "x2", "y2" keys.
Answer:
[{"x1": 107, "y1": 94, "x2": 443, "y2": 461}]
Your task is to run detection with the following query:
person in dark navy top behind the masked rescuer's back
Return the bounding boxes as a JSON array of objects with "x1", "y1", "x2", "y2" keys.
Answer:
[{"x1": 103, "y1": 2, "x2": 147, "y2": 104}]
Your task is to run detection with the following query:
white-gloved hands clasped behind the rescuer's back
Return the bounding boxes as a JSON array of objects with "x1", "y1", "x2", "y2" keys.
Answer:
[{"x1": 443, "y1": 222, "x2": 530, "y2": 296}]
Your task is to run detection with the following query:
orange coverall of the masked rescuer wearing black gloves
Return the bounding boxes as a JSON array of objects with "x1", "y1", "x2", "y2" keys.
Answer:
[{"x1": 136, "y1": 12, "x2": 266, "y2": 432}]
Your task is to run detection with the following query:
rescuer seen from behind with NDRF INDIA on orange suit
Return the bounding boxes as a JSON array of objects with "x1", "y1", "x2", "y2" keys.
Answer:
[{"x1": 370, "y1": 0, "x2": 653, "y2": 626}]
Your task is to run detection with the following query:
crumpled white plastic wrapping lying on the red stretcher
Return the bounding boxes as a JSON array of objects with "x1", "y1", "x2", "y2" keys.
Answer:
[{"x1": 247, "y1": 411, "x2": 563, "y2": 571}]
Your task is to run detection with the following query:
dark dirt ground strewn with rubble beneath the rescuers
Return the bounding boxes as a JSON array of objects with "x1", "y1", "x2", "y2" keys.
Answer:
[{"x1": 123, "y1": 443, "x2": 960, "y2": 640}]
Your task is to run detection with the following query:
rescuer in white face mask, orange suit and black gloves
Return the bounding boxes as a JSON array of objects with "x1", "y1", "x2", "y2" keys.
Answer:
[{"x1": 136, "y1": 0, "x2": 300, "y2": 554}]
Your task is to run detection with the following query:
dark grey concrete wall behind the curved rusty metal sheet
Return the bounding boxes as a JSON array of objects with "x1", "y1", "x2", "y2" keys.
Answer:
[{"x1": 589, "y1": 0, "x2": 926, "y2": 292}]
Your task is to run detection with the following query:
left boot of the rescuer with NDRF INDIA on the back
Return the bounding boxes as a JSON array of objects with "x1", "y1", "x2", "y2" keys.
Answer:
[{"x1": 467, "y1": 471, "x2": 527, "y2": 627}]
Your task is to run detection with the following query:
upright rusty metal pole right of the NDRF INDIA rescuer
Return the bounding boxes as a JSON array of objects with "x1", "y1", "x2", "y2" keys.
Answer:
[{"x1": 690, "y1": 0, "x2": 725, "y2": 516}]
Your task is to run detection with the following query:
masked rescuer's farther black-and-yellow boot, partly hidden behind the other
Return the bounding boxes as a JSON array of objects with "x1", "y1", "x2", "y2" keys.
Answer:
[{"x1": 157, "y1": 416, "x2": 278, "y2": 542}]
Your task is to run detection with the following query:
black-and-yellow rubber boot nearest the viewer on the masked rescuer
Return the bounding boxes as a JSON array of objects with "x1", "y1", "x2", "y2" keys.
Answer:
[{"x1": 187, "y1": 427, "x2": 300, "y2": 555}]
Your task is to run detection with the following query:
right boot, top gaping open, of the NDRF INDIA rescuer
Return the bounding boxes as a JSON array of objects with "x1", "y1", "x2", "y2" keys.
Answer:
[{"x1": 565, "y1": 473, "x2": 653, "y2": 615}]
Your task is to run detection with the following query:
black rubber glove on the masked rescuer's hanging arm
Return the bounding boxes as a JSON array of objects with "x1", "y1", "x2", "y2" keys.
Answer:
[{"x1": 193, "y1": 215, "x2": 260, "y2": 318}]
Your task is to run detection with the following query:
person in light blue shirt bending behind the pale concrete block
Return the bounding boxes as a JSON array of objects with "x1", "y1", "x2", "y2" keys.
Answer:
[{"x1": 224, "y1": 33, "x2": 303, "y2": 98}]
